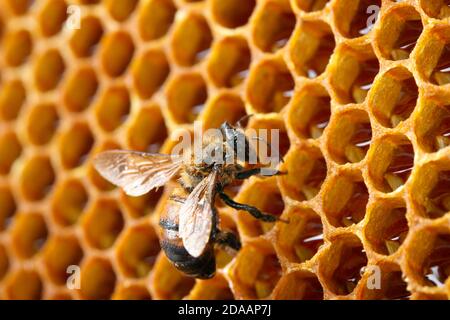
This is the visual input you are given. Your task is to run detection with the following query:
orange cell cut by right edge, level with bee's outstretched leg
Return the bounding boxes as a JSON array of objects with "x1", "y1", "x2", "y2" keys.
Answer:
[{"x1": 411, "y1": 158, "x2": 450, "y2": 219}]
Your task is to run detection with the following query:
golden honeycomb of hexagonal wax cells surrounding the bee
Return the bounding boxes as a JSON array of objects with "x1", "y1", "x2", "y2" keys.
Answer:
[{"x1": 0, "y1": 0, "x2": 450, "y2": 299}]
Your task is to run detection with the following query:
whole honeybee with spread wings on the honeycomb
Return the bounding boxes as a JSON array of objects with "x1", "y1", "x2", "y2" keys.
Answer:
[{"x1": 94, "y1": 122, "x2": 280, "y2": 279}]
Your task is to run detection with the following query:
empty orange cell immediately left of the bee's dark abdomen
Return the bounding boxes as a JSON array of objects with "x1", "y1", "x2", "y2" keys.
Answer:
[{"x1": 117, "y1": 224, "x2": 160, "y2": 278}]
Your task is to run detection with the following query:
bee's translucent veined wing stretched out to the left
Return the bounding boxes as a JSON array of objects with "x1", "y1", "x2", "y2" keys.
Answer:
[{"x1": 94, "y1": 150, "x2": 181, "y2": 197}]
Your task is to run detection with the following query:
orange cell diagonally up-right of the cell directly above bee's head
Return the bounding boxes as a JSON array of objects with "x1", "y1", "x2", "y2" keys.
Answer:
[{"x1": 246, "y1": 59, "x2": 295, "y2": 113}]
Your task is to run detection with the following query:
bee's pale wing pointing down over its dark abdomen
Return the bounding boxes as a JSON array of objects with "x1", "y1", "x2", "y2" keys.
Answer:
[{"x1": 179, "y1": 172, "x2": 216, "y2": 258}]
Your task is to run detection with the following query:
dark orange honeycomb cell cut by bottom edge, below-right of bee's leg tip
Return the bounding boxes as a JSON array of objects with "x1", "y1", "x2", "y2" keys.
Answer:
[{"x1": 272, "y1": 271, "x2": 323, "y2": 300}]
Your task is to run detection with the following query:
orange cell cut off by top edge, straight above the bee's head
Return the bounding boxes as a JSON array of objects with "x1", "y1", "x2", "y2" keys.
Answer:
[{"x1": 211, "y1": 0, "x2": 256, "y2": 28}]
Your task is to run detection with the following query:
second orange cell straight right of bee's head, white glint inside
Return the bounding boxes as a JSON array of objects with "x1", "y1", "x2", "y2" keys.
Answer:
[{"x1": 328, "y1": 110, "x2": 372, "y2": 163}]
